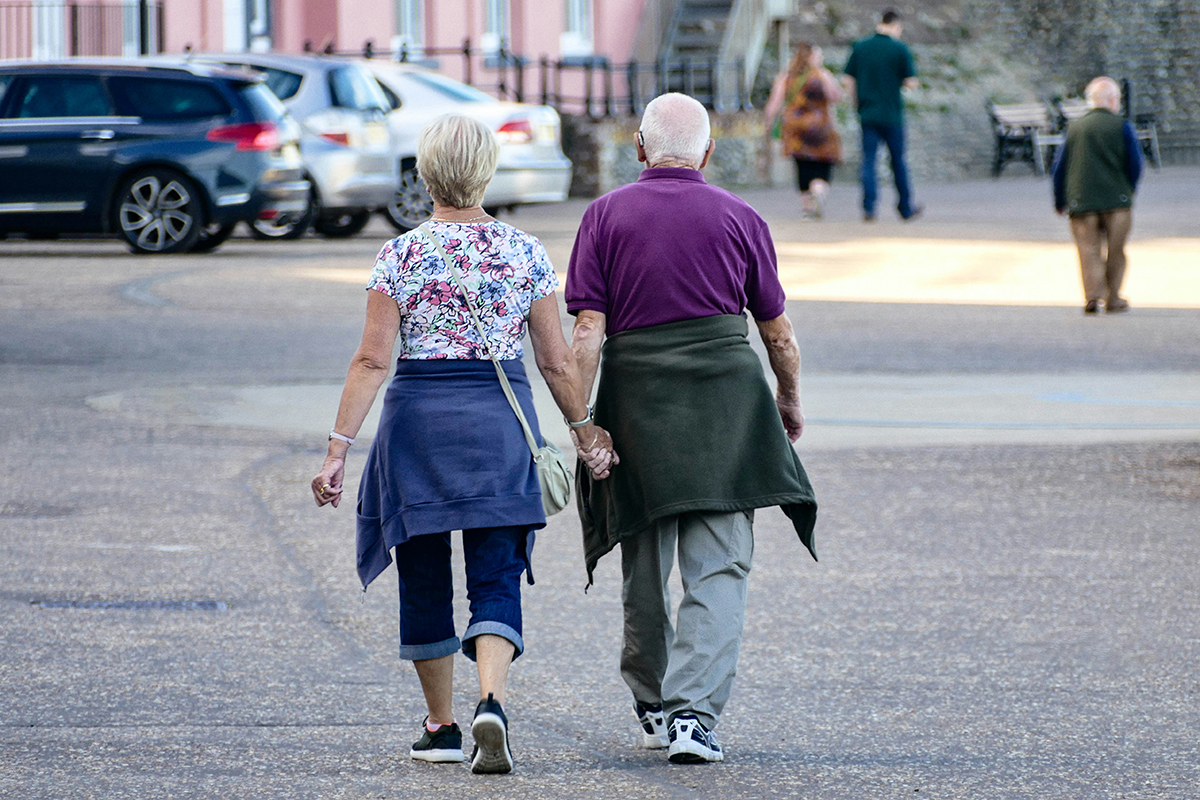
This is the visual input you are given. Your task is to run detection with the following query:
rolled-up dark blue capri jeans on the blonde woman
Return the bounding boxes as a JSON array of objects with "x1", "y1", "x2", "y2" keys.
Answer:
[{"x1": 396, "y1": 527, "x2": 532, "y2": 661}]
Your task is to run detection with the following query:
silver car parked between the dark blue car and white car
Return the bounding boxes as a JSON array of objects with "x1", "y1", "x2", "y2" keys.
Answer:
[{"x1": 193, "y1": 53, "x2": 400, "y2": 239}]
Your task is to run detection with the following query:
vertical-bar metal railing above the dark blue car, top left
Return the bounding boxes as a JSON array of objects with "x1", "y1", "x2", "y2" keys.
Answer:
[{"x1": 0, "y1": 0, "x2": 164, "y2": 59}]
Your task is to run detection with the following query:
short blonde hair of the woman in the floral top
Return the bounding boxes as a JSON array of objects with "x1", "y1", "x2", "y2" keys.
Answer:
[{"x1": 416, "y1": 114, "x2": 500, "y2": 209}]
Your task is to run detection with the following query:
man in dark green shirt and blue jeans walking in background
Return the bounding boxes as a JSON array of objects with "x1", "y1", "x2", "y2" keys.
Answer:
[{"x1": 845, "y1": 8, "x2": 923, "y2": 222}]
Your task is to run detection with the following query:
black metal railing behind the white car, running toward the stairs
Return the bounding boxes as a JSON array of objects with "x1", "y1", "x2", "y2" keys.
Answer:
[{"x1": 319, "y1": 38, "x2": 754, "y2": 119}]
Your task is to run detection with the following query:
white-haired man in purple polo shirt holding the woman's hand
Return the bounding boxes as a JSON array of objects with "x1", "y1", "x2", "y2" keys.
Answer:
[{"x1": 566, "y1": 94, "x2": 816, "y2": 764}]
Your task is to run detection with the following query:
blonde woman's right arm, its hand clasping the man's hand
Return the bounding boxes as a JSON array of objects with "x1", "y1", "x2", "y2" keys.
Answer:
[{"x1": 529, "y1": 294, "x2": 620, "y2": 479}]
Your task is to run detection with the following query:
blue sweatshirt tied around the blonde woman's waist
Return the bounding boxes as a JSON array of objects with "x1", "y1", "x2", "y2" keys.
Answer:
[{"x1": 358, "y1": 359, "x2": 546, "y2": 588}]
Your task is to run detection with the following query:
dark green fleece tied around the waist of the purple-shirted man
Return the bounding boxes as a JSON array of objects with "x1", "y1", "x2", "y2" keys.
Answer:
[{"x1": 576, "y1": 314, "x2": 817, "y2": 584}]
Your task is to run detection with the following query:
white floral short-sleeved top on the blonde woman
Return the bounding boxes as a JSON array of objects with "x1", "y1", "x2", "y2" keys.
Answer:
[{"x1": 367, "y1": 222, "x2": 558, "y2": 360}]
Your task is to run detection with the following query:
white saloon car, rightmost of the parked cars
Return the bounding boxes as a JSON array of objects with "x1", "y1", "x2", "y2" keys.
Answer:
[{"x1": 361, "y1": 60, "x2": 571, "y2": 233}]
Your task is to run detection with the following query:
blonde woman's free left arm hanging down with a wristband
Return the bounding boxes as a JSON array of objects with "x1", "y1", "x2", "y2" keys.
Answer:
[{"x1": 312, "y1": 290, "x2": 400, "y2": 509}]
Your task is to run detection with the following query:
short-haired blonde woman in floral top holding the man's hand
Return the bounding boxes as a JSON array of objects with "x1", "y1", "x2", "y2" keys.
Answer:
[{"x1": 312, "y1": 115, "x2": 618, "y2": 772}]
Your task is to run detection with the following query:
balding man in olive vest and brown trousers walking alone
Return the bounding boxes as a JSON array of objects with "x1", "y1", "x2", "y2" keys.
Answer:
[{"x1": 1054, "y1": 77, "x2": 1142, "y2": 314}]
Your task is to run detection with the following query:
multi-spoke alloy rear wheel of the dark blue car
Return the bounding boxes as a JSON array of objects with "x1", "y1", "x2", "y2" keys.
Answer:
[{"x1": 116, "y1": 169, "x2": 203, "y2": 253}]
